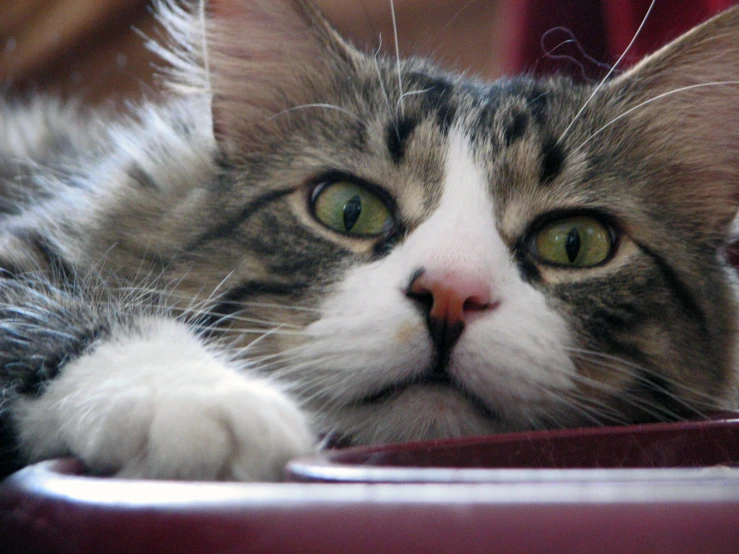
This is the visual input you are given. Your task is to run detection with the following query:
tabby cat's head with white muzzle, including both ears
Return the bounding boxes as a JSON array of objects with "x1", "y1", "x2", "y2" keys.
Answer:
[{"x1": 165, "y1": 0, "x2": 739, "y2": 443}]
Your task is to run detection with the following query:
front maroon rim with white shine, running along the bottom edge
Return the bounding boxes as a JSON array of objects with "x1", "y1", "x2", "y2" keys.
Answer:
[{"x1": 0, "y1": 452, "x2": 739, "y2": 554}]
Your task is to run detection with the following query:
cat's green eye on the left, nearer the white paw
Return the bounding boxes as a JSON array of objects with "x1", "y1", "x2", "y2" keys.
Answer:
[{"x1": 313, "y1": 181, "x2": 393, "y2": 236}]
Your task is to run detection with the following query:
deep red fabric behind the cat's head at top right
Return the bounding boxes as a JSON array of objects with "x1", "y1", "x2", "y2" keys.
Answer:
[{"x1": 507, "y1": 0, "x2": 739, "y2": 80}]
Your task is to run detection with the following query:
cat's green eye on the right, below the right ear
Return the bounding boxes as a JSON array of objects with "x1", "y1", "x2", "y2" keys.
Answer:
[{"x1": 534, "y1": 216, "x2": 613, "y2": 267}]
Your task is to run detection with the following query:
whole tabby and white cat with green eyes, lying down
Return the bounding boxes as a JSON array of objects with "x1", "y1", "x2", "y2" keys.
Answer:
[{"x1": 0, "y1": 0, "x2": 739, "y2": 481}]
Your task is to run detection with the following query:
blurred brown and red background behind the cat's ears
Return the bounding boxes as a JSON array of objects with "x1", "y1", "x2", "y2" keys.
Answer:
[{"x1": 0, "y1": 0, "x2": 739, "y2": 104}]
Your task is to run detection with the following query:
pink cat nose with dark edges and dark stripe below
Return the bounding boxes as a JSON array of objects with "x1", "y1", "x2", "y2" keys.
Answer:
[{"x1": 406, "y1": 271, "x2": 497, "y2": 352}]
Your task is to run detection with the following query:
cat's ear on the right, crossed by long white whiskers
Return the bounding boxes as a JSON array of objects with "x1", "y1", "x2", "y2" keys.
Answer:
[{"x1": 609, "y1": 7, "x2": 739, "y2": 234}]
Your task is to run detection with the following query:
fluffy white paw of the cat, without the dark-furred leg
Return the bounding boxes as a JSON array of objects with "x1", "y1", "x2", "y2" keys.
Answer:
[{"x1": 18, "y1": 320, "x2": 314, "y2": 481}]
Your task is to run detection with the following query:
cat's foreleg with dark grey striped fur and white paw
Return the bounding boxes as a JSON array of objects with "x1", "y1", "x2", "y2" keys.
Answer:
[{"x1": 0, "y1": 280, "x2": 313, "y2": 480}]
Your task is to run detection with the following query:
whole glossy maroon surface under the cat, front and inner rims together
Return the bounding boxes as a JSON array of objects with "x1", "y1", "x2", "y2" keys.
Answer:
[{"x1": 0, "y1": 417, "x2": 739, "y2": 554}]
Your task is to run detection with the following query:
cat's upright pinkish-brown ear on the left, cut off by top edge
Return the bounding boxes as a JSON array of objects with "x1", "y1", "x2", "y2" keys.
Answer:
[{"x1": 207, "y1": 0, "x2": 357, "y2": 157}]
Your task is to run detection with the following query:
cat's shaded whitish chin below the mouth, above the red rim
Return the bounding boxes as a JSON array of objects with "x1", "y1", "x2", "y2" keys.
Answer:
[{"x1": 325, "y1": 382, "x2": 515, "y2": 445}]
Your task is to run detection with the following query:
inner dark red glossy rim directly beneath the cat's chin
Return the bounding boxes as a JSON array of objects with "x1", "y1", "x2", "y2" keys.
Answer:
[{"x1": 288, "y1": 413, "x2": 739, "y2": 484}]
